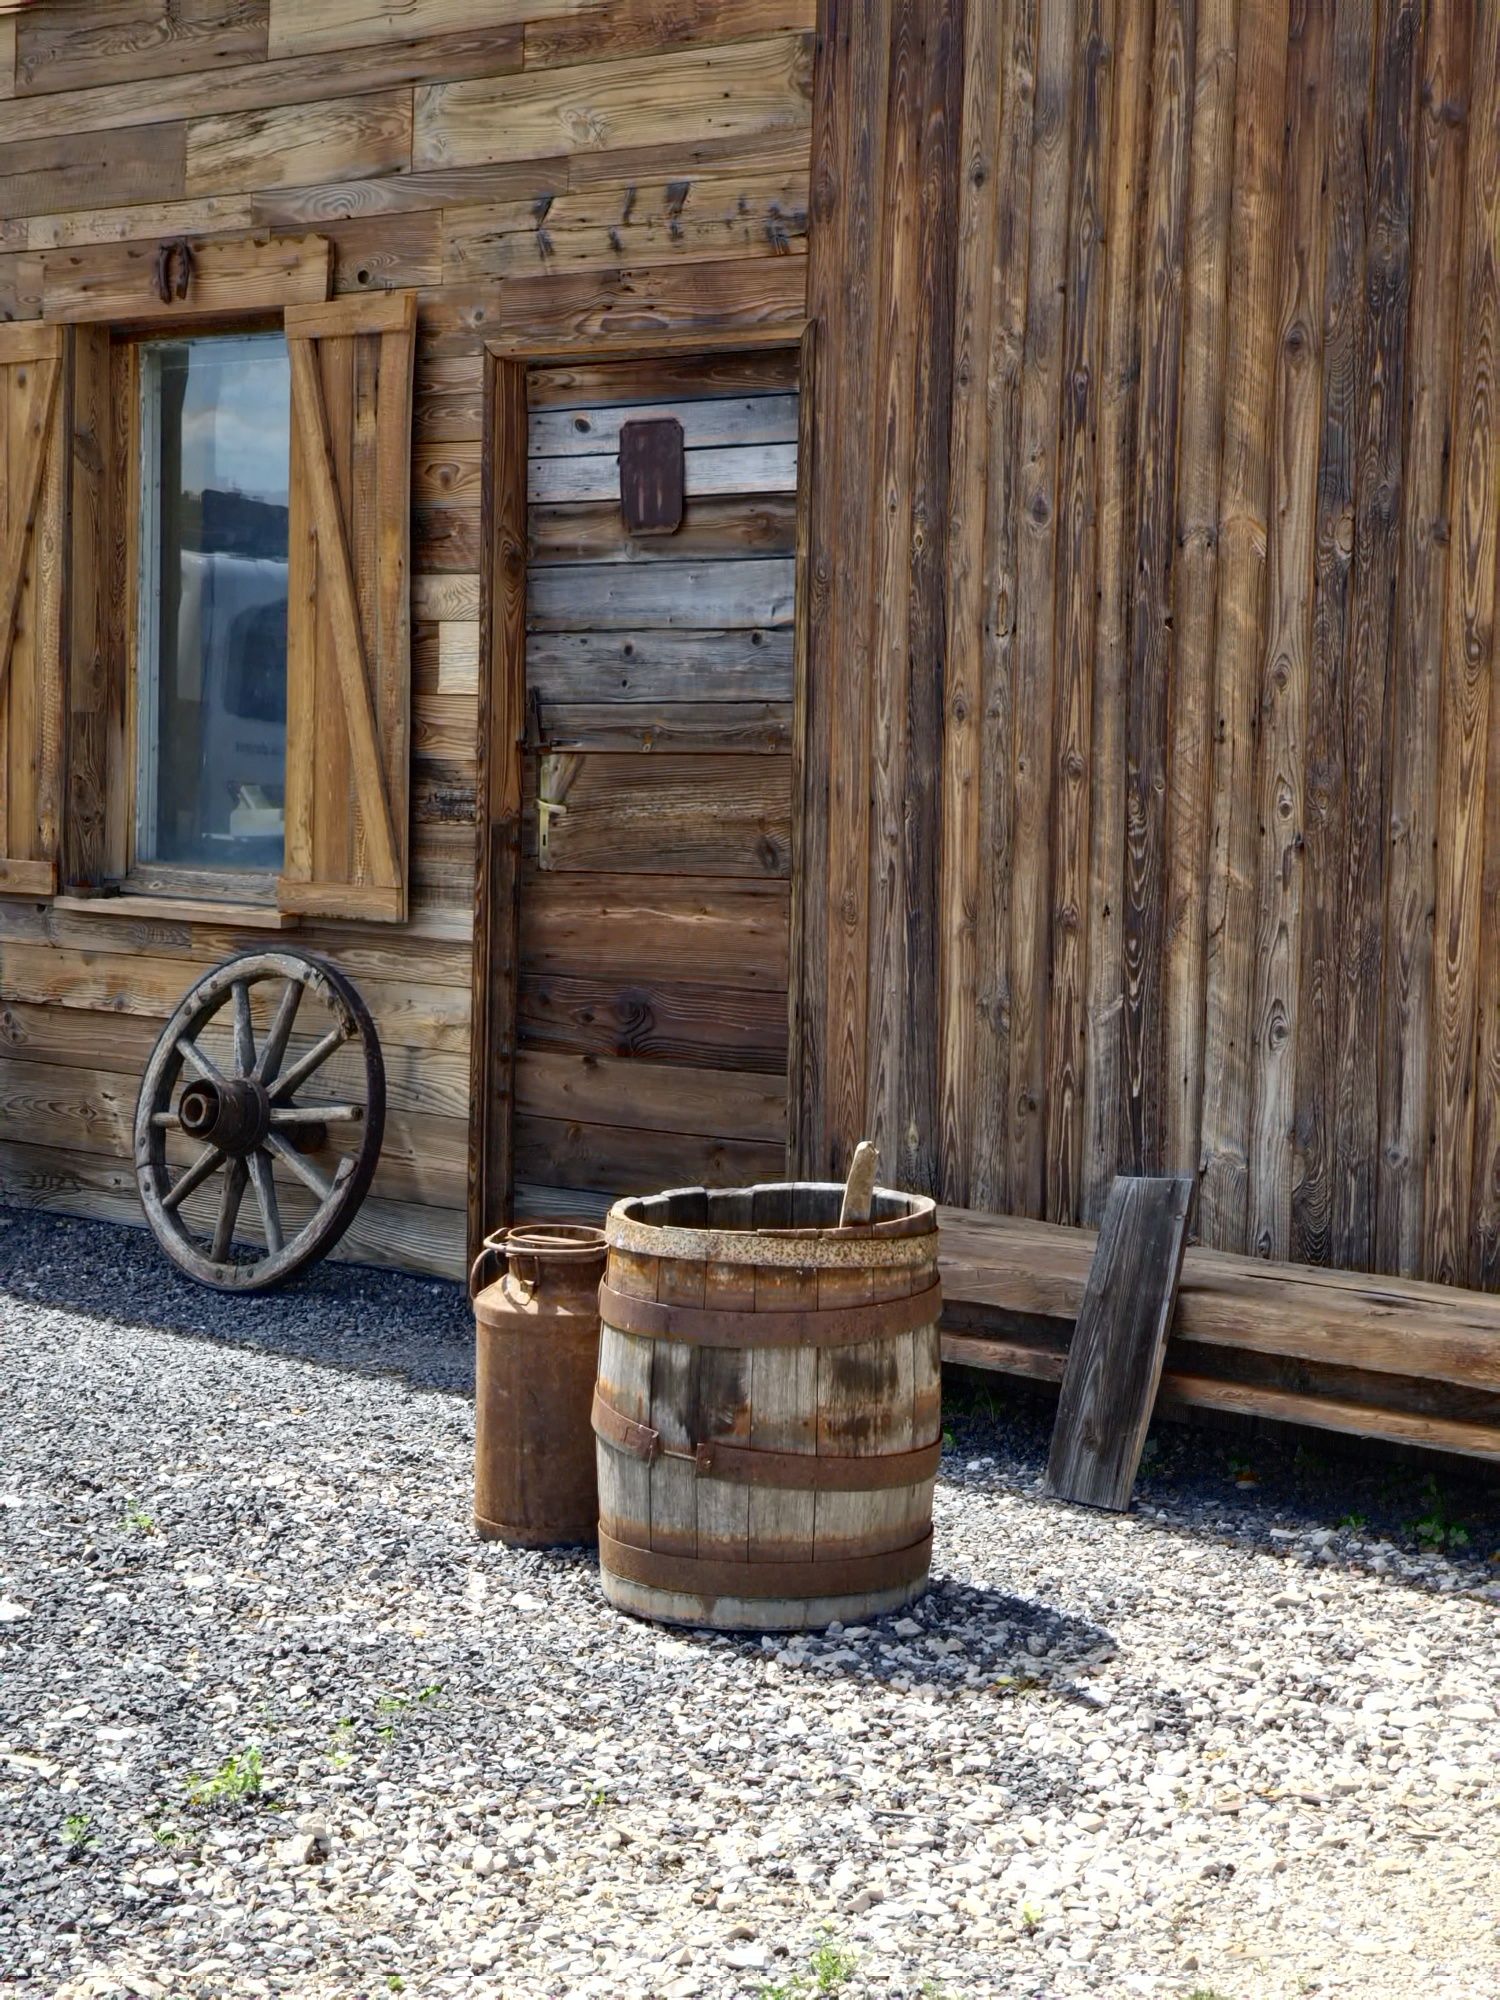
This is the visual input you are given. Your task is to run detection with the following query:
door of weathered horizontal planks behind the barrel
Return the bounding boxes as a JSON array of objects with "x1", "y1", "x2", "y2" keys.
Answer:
[{"x1": 512, "y1": 352, "x2": 798, "y2": 1216}]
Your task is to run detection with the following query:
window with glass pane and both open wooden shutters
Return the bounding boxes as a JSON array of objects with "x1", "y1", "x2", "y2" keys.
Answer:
[{"x1": 0, "y1": 278, "x2": 416, "y2": 922}]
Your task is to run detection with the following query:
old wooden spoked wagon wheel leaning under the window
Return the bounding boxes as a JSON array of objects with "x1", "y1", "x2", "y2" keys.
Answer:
[{"x1": 136, "y1": 952, "x2": 386, "y2": 1292}]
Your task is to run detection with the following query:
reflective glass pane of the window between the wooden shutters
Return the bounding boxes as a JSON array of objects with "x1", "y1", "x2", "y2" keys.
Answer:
[{"x1": 136, "y1": 334, "x2": 290, "y2": 870}]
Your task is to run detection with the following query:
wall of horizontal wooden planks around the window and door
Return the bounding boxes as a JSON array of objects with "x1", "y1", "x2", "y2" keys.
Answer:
[{"x1": 0, "y1": 0, "x2": 812, "y2": 1274}]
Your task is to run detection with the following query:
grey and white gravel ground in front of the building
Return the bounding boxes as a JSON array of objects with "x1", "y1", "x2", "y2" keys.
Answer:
[{"x1": 0, "y1": 1210, "x2": 1500, "y2": 2000}]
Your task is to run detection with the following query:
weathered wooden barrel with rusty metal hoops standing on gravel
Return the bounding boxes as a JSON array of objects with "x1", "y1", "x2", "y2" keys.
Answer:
[{"x1": 594, "y1": 1182, "x2": 942, "y2": 1632}]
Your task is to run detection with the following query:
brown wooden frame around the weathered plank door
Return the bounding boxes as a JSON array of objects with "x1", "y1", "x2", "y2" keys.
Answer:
[{"x1": 468, "y1": 318, "x2": 816, "y2": 1262}]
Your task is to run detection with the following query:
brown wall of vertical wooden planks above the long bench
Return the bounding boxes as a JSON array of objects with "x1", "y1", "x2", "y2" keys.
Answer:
[{"x1": 812, "y1": 0, "x2": 1500, "y2": 1284}]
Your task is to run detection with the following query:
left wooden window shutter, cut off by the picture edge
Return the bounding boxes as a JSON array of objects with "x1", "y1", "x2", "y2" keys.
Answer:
[{"x1": 0, "y1": 320, "x2": 68, "y2": 896}]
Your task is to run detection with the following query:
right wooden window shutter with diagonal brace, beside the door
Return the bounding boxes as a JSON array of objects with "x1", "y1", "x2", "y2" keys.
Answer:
[{"x1": 278, "y1": 292, "x2": 416, "y2": 922}]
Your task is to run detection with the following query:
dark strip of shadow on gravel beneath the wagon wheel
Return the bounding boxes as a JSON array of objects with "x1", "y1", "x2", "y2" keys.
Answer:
[{"x1": 0, "y1": 1204, "x2": 474, "y2": 1396}]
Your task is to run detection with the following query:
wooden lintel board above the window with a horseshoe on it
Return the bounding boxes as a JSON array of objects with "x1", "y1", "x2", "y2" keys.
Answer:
[{"x1": 42, "y1": 236, "x2": 334, "y2": 326}]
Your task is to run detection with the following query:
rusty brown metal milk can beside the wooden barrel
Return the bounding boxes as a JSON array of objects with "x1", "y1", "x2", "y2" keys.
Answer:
[{"x1": 470, "y1": 1222, "x2": 604, "y2": 1548}]
